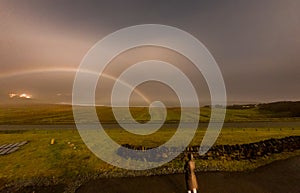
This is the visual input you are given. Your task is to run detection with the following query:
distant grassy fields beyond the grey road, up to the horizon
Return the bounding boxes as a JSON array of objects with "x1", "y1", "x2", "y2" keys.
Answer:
[{"x1": 0, "y1": 102, "x2": 300, "y2": 124}]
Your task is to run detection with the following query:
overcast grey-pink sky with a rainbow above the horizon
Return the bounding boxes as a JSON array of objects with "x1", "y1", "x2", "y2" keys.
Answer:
[{"x1": 0, "y1": 0, "x2": 300, "y2": 104}]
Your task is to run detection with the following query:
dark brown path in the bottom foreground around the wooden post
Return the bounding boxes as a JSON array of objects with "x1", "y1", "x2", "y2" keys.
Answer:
[{"x1": 76, "y1": 157, "x2": 300, "y2": 193}]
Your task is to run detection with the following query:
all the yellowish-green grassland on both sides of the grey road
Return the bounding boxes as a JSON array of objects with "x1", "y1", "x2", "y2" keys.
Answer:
[{"x1": 0, "y1": 104, "x2": 300, "y2": 190}]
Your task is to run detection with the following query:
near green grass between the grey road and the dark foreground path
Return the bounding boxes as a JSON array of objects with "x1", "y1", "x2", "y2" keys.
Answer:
[{"x1": 0, "y1": 128, "x2": 300, "y2": 185}]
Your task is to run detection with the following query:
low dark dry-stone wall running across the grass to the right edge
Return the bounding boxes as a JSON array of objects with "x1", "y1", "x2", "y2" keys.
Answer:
[{"x1": 117, "y1": 136, "x2": 300, "y2": 162}]
